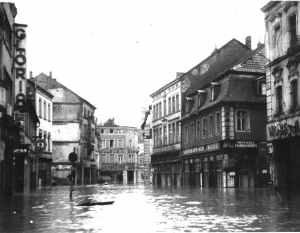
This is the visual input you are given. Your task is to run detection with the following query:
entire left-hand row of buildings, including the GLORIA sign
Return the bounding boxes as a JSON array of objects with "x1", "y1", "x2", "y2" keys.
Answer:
[{"x1": 0, "y1": 3, "x2": 100, "y2": 194}]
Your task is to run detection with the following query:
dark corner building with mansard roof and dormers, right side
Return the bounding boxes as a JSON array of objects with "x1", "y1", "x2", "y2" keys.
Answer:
[{"x1": 181, "y1": 37, "x2": 268, "y2": 187}]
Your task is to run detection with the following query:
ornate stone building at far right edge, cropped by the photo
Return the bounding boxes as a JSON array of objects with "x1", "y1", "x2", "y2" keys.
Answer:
[{"x1": 262, "y1": 1, "x2": 300, "y2": 190}]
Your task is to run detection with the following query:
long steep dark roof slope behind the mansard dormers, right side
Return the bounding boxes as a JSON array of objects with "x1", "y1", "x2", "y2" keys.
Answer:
[{"x1": 183, "y1": 39, "x2": 251, "y2": 95}]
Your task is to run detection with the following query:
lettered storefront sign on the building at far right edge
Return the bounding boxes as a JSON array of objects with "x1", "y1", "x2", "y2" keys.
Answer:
[{"x1": 267, "y1": 119, "x2": 300, "y2": 140}]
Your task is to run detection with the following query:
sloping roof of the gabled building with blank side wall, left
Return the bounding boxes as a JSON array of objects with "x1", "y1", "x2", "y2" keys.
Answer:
[{"x1": 33, "y1": 73, "x2": 96, "y2": 109}]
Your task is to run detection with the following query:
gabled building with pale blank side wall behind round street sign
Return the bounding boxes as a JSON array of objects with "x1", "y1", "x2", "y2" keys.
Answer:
[{"x1": 33, "y1": 72, "x2": 97, "y2": 184}]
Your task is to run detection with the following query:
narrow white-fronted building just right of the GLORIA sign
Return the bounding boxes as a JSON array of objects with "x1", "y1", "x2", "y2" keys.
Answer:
[{"x1": 27, "y1": 79, "x2": 53, "y2": 187}]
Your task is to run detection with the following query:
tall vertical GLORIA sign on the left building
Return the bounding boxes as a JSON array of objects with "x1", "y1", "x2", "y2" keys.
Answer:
[{"x1": 14, "y1": 24, "x2": 27, "y2": 112}]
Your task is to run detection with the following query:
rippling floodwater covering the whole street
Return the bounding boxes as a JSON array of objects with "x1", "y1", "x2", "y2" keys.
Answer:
[{"x1": 0, "y1": 185, "x2": 300, "y2": 233}]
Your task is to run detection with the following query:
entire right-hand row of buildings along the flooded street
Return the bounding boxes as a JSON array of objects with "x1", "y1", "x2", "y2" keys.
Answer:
[{"x1": 143, "y1": 1, "x2": 300, "y2": 189}]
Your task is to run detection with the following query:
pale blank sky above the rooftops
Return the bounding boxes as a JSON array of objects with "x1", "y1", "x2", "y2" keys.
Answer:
[{"x1": 14, "y1": 0, "x2": 267, "y2": 127}]
